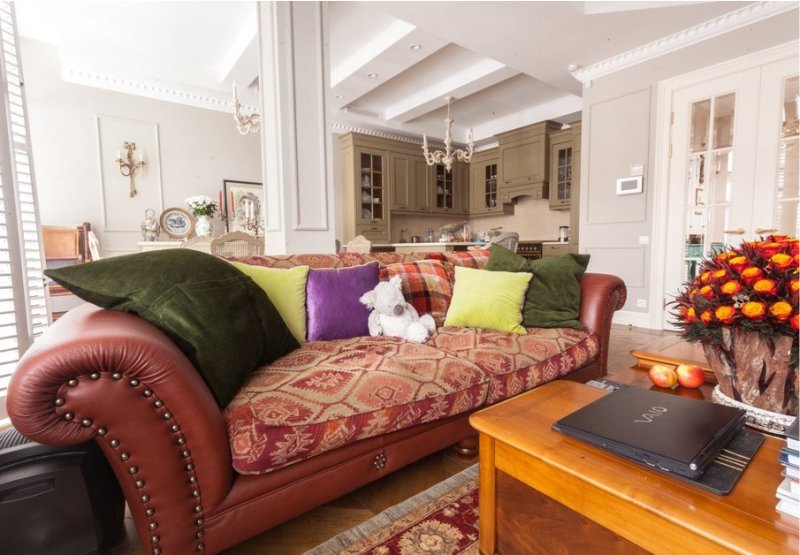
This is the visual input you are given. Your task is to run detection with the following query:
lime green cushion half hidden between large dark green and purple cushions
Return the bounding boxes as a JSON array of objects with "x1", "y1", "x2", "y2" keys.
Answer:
[{"x1": 231, "y1": 262, "x2": 308, "y2": 343}]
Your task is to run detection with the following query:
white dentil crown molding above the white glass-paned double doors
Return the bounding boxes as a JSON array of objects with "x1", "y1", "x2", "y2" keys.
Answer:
[{"x1": 570, "y1": 1, "x2": 797, "y2": 87}]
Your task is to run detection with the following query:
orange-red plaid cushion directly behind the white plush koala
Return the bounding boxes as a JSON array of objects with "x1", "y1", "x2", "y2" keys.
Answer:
[{"x1": 380, "y1": 260, "x2": 453, "y2": 326}]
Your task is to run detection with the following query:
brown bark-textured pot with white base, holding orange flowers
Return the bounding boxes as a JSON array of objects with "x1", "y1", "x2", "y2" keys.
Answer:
[{"x1": 703, "y1": 328, "x2": 798, "y2": 434}]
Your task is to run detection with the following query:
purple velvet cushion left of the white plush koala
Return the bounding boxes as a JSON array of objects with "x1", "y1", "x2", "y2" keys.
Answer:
[{"x1": 306, "y1": 262, "x2": 378, "y2": 341}]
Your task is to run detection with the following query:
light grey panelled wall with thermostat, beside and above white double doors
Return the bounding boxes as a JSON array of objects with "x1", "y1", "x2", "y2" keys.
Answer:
[{"x1": 579, "y1": 10, "x2": 798, "y2": 327}]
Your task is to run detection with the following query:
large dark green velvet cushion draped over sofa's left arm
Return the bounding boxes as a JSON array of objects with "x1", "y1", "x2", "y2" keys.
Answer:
[{"x1": 45, "y1": 249, "x2": 299, "y2": 407}]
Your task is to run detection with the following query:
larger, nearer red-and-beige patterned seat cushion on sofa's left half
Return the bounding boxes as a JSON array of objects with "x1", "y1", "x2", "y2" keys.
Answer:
[{"x1": 223, "y1": 336, "x2": 488, "y2": 474}]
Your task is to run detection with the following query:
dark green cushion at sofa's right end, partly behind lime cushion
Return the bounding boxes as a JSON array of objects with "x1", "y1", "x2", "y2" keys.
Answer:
[{"x1": 487, "y1": 244, "x2": 589, "y2": 330}]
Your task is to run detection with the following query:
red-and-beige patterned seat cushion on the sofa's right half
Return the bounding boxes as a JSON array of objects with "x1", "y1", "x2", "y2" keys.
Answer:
[{"x1": 427, "y1": 327, "x2": 600, "y2": 404}]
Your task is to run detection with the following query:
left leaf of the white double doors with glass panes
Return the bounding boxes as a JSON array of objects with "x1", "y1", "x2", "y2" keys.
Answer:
[{"x1": 664, "y1": 68, "x2": 760, "y2": 327}]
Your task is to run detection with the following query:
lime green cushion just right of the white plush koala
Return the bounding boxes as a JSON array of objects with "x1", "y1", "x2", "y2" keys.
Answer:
[{"x1": 444, "y1": 266, "x2": 531, "y2": 335}]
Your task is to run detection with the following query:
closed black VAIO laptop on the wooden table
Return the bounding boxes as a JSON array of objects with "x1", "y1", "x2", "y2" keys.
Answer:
[{"x1": 553, "y1": 387, "x2": 745, "y2": 480}]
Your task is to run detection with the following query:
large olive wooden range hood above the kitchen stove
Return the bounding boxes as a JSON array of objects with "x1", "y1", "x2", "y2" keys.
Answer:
[{"x1": 497, "y1": 121, "x2": 561, "y2": 203}]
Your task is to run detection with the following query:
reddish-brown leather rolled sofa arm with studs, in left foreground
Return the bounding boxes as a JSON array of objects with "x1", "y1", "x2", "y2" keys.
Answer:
[{"x1": 8, "y1": 305, "x2": 233, "y2": 553}]
